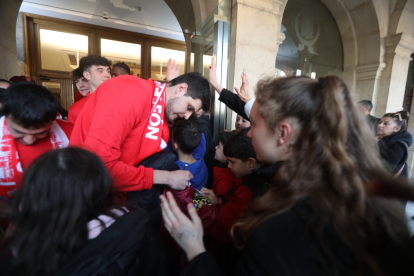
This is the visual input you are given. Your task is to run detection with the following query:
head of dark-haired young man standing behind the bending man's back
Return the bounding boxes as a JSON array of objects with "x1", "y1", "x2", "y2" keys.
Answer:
[{"x1": 79, "y1": 55, "x2": 112, "y2": 94}]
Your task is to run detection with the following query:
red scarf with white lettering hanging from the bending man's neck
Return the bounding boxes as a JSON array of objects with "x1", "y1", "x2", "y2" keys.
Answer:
[{"x1": 134, "y1": 81, "x2": 169, "y2": 166}]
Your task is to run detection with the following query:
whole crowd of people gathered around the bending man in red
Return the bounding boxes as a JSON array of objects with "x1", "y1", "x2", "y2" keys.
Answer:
[{"x1": 0, "y1": 52, "x2": 414, "y2": 275}]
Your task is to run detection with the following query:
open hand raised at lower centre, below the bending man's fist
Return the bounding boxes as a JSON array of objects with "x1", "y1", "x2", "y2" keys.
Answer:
[{"x1": 160, "y1": 192, "x2": 206, "y2": 261}]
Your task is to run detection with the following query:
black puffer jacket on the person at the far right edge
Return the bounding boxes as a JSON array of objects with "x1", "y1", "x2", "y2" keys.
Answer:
[{"x1": 378, "y1": 130, "x2": 414, "y2": 178}]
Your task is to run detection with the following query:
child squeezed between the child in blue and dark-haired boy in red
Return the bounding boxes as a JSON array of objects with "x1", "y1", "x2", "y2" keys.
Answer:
[{"x1": 212, "y1": 132, "x2": 236, "y2": 195}]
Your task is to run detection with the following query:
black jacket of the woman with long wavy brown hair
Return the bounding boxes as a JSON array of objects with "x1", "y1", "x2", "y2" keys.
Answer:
[{"x1": 181, "y1": 199, "x2": 414, "y2": 276}]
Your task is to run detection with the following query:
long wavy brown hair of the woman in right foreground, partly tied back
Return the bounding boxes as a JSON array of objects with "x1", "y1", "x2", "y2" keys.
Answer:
[{"x1": 234, "y1": 76, "x2": 410, "y2": 275}]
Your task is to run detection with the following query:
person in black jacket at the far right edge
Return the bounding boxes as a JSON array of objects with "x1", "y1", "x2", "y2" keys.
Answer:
[{"x1": 377, "y1": 111, "x2": 414, "y2": 178}]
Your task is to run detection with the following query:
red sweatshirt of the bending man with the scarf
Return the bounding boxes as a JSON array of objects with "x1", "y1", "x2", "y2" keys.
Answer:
[{"x1": 69, "y1": 75, "x2": 158, "y2": 192}]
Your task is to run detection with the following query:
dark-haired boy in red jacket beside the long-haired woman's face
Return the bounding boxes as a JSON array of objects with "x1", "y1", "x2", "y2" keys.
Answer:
[{"x1": 201, "y1": 128, "x2": 266, "y2": 244}]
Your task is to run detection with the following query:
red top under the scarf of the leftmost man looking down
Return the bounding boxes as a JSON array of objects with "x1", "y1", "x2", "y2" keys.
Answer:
[{"x1": 16, "y1": 120, "x2": 73, "y2": 171}]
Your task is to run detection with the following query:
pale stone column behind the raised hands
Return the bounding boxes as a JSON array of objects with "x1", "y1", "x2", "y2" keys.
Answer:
[{"x1": 227, "y1": 0, "x2": 287, "y2": 129}]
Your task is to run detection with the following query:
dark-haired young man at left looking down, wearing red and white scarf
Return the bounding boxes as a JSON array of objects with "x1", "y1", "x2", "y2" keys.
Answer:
[{"x1": 0, "y1": 83, "x2": 73, "y2": 198}]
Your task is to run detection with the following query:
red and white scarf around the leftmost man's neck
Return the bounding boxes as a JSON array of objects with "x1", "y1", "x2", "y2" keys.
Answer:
[{"x1": 0, "y1": 116, "x2": 69, "y2": 198}]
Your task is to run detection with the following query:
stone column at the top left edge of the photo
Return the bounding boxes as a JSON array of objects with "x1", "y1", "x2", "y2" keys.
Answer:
[{"x1": 0, "y1": 0, "x2": 22, "y2": 79}]
